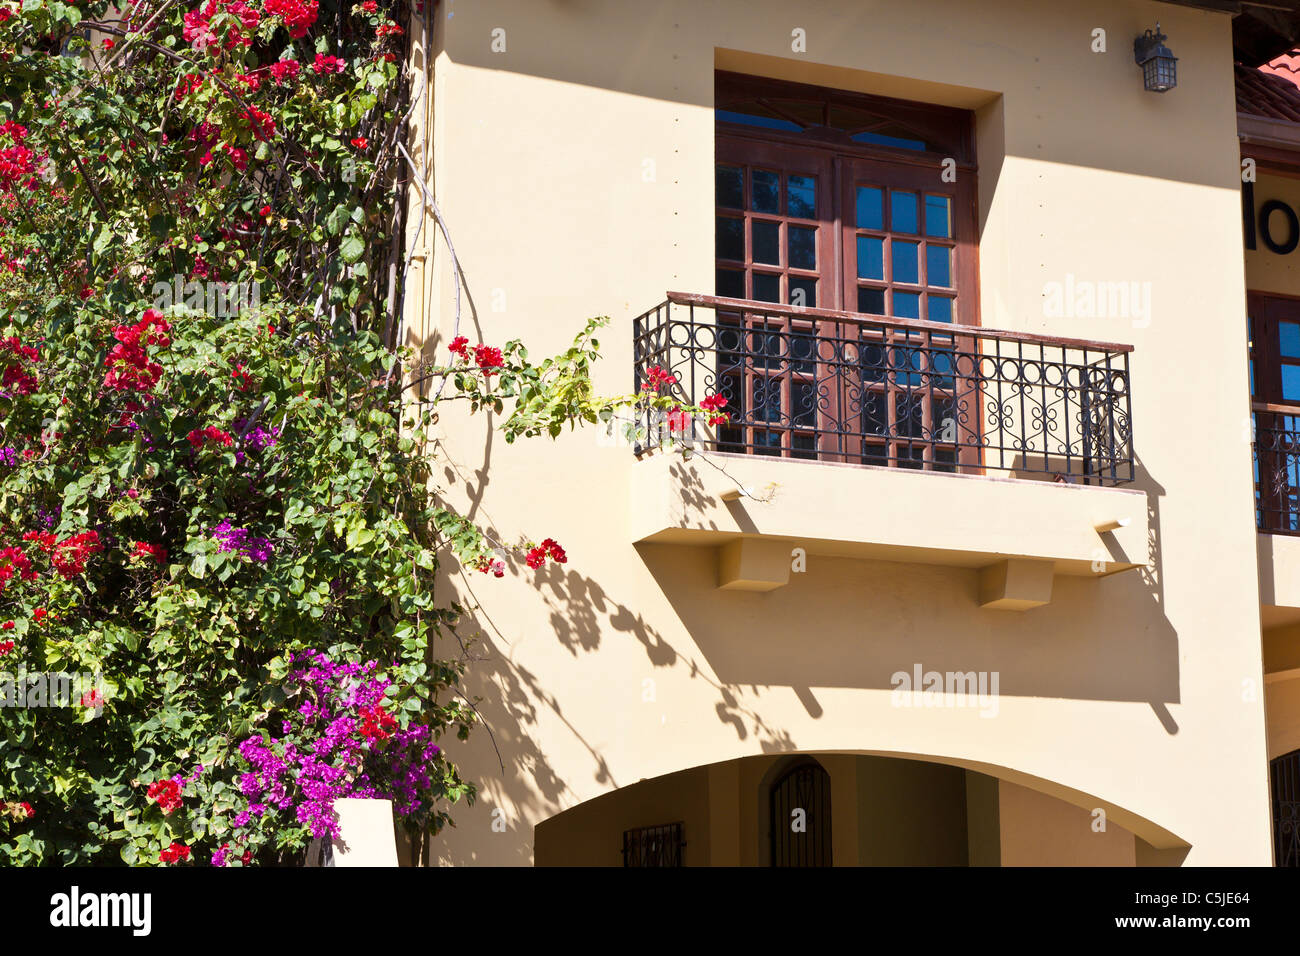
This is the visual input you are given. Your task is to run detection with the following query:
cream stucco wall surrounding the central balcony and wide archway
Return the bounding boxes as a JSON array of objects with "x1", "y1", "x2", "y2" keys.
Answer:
[{"x1": 407, "y1": 0, "x2": 1270, "y2": 865}]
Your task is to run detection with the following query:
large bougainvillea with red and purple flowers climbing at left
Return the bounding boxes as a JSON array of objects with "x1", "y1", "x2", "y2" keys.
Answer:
[{"x1": 0, "y1": 0, "x2": 725, "y2": 866}]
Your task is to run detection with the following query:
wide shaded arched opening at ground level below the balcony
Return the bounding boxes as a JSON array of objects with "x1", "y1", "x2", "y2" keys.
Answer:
[{"x1": 533, "y1": 752, "x2": 1186, "y2": 866}]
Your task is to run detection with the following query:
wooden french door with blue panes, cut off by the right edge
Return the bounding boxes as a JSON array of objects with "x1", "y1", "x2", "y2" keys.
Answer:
[{"x1": 1247, "y1": 293, "x2": 1300, "y2": 532}]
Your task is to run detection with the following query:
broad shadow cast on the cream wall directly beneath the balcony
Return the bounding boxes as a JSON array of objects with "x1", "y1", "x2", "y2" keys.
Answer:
[{"x1": 639, "y1": 450, "x2": 1179, "y2": 712}]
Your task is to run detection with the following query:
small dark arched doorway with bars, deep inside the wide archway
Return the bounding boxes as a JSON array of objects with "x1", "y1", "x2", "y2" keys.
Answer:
[{"x1": 767, "y1": 757, "x2": 835, "y2": 866}]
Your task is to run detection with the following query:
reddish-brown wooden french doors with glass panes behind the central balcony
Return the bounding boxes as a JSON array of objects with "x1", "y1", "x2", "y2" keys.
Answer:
[{"x1": 715, "y1": 131, "x2": 980, "y2": 471}]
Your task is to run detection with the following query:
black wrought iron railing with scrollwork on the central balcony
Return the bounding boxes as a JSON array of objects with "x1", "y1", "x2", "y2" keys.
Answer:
[{"x1": 633, "y1": 293, "x2": 1134, "y2": 485}]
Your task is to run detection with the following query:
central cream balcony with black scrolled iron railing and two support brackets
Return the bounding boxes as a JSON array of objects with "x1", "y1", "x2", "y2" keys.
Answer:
[{"x1": 629, "y1": 293, "x2": 1148, "y2": 610}]
